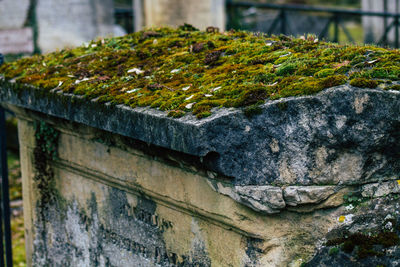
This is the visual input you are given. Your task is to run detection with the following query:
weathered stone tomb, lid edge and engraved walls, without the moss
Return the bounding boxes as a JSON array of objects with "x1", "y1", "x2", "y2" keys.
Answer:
[{"x1": 0, "y1": 81, "x2": 400, "y2": 266}]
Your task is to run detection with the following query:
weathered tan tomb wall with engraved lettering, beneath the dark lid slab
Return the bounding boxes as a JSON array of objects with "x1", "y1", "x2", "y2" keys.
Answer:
[{"x1": 7, "y1": 101, "x2": 400, "y2": 266}]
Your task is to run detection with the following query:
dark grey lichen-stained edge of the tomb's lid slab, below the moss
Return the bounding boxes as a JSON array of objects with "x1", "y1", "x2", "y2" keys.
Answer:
[{"x1": 0, "y1": 81, "x2": 400, "y2": 188}]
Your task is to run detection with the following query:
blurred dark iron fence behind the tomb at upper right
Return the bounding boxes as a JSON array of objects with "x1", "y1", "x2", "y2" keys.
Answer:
[{"x1": 226, "y1": 0, "x2": 400, "y2": 48}]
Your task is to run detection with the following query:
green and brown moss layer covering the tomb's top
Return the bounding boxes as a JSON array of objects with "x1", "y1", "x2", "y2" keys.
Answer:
[{"x1": 0, "y1": 25, "x2": 400, "y2": 118}]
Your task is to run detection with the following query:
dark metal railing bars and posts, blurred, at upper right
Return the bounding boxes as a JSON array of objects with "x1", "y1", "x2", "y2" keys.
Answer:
[{"x1": 226, "y1": 0, "x2": 400, "y2": 48}]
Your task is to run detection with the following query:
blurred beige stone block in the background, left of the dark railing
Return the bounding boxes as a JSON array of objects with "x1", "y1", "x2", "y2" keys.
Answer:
[{"x1": 134, "y1": 0, "x2": 226, "y2": 30}]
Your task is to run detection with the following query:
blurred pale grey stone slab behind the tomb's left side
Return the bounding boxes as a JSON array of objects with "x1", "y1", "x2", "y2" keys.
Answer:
[{"x1": 36, "y1": 0, "x2": 114, "y2": 52}]
